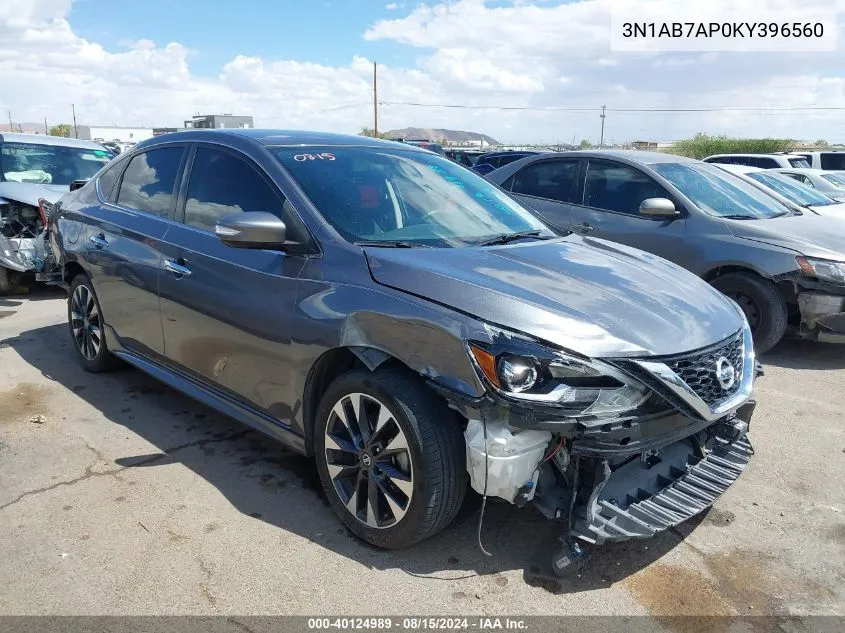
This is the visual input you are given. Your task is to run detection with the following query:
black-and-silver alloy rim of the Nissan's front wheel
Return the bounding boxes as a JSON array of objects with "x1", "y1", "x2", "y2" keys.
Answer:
[{"x1": 325, "y1": 393, "x2": 414, "y2": 528}]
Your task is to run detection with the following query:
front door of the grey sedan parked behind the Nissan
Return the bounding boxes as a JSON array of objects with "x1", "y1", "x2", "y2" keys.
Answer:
[{"x1": 570, "y1": 158, "x2": 688, "y2": 266}]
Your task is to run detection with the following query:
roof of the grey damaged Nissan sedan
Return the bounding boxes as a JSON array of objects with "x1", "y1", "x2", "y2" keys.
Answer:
[{"x1": 136, "y1": 128, "x2": 426, "y2": 152}]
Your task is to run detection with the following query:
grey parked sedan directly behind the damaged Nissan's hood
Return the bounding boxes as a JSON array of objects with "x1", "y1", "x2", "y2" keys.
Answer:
[{"x1": 487, "y1": 151, "x2": 845, "y2": 352}]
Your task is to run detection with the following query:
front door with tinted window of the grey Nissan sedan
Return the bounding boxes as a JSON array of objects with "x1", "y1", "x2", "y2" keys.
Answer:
[{"x1": 160, "y1": 144, "x2": 305, "y2": 421}]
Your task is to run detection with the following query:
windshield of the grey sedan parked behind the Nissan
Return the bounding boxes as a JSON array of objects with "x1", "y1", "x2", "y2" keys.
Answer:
[{"x1": 652, "y1": 163, "x2": 791, "y2": 220}]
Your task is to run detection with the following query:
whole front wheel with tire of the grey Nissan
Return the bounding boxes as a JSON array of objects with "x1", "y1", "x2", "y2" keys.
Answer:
[{"x1": 314, "y1": 365, "x2": 467, "y2": 549}]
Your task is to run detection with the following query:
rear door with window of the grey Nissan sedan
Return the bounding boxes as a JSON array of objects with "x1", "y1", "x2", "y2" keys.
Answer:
[{"x1": 86, "y1": 144, "x2": 186, "y2": 357}]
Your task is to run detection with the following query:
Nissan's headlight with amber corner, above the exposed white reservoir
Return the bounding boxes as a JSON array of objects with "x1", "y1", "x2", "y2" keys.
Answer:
[{"x1": 468, "y1": 328, "x2": 651, "y2": 417}]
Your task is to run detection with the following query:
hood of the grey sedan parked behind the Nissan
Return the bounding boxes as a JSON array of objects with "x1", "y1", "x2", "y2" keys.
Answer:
[{"x1": 725, "y1": 214, "x2": 845, "y2": 261}]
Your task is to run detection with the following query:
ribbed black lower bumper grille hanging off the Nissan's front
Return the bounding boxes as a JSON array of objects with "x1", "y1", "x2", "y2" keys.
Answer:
[{"x1": 572, "y1": 437, "x2": 754, "y2": 543}]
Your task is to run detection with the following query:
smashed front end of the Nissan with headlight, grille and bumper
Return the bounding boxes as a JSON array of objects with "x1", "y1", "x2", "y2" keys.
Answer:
[{"x1": 454, "y1": 323, "x2": 759, "y2": 572}]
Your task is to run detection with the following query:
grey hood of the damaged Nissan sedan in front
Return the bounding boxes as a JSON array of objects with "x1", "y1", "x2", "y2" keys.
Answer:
[{"x1": 364, "y1": 235, "x2": 742, "y2": 357}]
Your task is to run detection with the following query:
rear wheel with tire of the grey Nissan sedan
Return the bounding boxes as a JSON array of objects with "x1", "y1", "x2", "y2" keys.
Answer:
[{"x1": 67, "y1": 274, "x2": 120, "y2": 373}]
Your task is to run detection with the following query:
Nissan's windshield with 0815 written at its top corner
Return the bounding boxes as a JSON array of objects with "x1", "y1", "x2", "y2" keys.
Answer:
[{"x1": 276, "y1": 147, "x2": 554, "y2": 247}]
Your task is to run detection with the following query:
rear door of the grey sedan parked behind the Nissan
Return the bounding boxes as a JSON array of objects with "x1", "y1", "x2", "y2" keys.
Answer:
[{"x1": 505, "y1": 158, "x2": 581, "y2": 232}]
